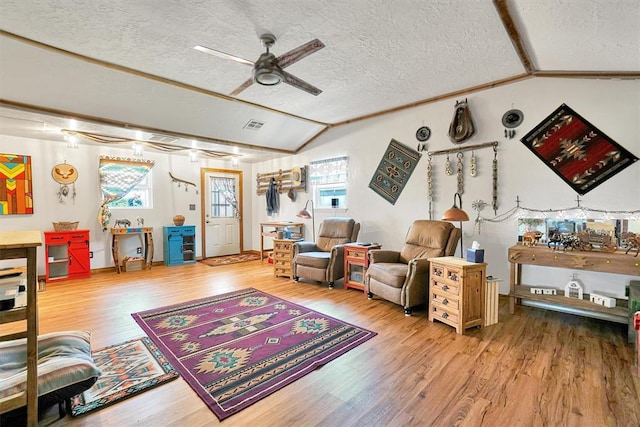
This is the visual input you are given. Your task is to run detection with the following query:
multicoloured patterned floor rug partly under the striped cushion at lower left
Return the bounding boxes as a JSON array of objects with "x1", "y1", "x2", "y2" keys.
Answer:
[{"x1": 71, "y1": 337, "x2": 179, "y2": 417}]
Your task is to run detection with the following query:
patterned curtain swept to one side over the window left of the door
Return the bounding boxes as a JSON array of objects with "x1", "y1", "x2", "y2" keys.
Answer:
[{"x1": 98, "y1": 156, "x2": 154, "y2": 230}]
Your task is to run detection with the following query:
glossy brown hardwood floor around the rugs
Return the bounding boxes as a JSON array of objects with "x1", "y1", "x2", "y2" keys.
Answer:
[{"x1": 2, "y1": 261, "x2": 640, "y2": 427}]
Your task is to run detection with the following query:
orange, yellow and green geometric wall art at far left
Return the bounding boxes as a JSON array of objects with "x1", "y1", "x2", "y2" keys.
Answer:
[{"x1": 0, "y1": 154, "x2": 33, "y2": 215}]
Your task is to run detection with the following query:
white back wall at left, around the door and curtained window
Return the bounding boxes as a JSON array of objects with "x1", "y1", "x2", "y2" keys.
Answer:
[{"x1": 0, "y1": 135, "x2": 252, "y2": 275}]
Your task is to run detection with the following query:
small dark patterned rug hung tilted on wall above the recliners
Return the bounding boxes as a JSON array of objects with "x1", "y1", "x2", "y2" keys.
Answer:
[{"x1": 369, "y1": 139, "x2": 421, "y2": 205}]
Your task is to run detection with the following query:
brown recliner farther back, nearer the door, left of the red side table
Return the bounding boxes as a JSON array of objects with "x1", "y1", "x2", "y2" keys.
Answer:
[{"x1": 293, "y1": 217, "x2": 360, "y2": 288}]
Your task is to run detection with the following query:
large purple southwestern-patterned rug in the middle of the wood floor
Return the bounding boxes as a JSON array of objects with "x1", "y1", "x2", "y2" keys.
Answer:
[{"x1": 132, "y1": 288, "x2": 376, "y2": 420}]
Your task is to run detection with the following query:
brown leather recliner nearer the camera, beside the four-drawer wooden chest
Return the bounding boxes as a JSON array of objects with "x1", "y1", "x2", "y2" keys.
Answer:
[{"x1": 365, "y1": 220, "x2": 462, "y2": 316}]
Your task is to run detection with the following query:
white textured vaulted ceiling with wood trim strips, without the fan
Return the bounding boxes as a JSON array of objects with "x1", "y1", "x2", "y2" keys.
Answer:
[{"x1": 0, "y1": 0, "x2": 640, "y2": 162}]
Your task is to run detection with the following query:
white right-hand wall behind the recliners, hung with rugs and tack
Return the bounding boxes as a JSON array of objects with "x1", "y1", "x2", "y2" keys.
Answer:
[{"x1": 253, "y1": 78, "x2": 640, "y2": 295}]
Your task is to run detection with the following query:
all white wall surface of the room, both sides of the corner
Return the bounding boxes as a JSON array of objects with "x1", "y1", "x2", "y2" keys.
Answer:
[{"x1": 0, "y1": 78, "x2": 640, "y2": 295}]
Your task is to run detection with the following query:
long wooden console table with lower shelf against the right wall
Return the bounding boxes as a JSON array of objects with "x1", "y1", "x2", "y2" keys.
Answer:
[{"x1": 509, "y1": 245, "x2": 640, "y2": 324}]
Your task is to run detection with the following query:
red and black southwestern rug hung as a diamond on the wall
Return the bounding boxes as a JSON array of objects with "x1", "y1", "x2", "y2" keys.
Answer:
[{"x1": 520, "y1": 104, "x2": 638, "y2": 195}]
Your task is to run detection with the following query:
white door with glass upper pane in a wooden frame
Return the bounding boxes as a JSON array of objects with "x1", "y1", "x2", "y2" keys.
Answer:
[{"x1": 203, "y1": 171, "x2": 242, "y2": 258}]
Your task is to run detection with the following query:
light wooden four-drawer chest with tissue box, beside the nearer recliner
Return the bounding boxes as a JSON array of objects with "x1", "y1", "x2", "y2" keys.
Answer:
[{"x1": 429, "y1": 257, "x2": 486, "y2": 334}]
